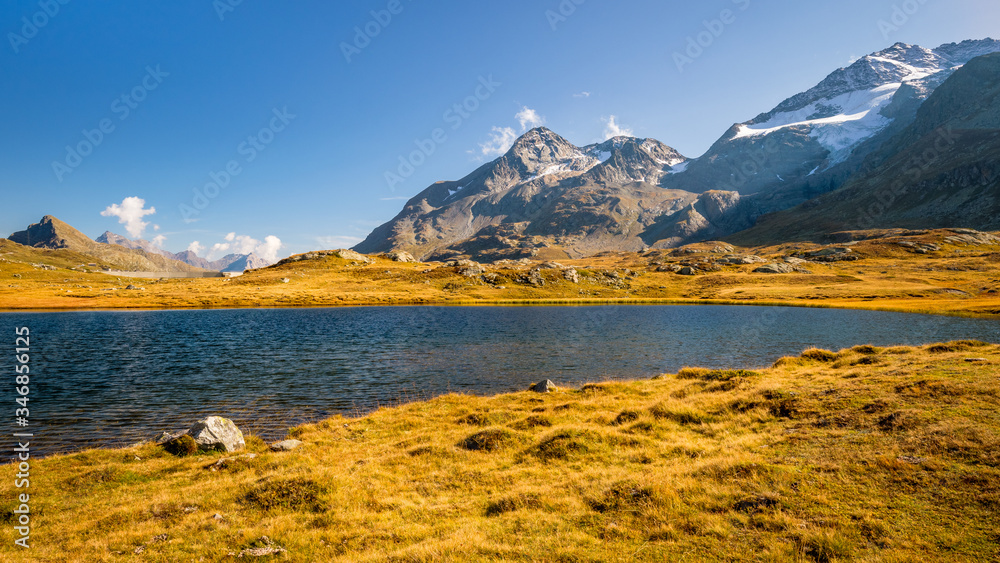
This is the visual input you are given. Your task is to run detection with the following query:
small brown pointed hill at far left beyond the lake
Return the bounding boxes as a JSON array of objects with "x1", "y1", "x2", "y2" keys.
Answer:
[{"x1": 7, "y1": 215, "x2": 212, "y2": 273}]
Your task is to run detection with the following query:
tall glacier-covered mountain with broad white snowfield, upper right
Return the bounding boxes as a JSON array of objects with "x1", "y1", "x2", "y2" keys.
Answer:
[{"x1": 663, "y1": 39, "x2": 1000, "y2": 221}]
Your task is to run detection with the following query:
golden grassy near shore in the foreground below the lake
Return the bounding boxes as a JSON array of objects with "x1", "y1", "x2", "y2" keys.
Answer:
[{"x1": 0, "y1": 342, "x2": 1000, "y2": 562}]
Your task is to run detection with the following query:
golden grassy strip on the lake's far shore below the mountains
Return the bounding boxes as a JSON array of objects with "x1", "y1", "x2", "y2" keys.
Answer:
[{"x1": 0, "y1": 231, "x2": 1000, "y2": 316}]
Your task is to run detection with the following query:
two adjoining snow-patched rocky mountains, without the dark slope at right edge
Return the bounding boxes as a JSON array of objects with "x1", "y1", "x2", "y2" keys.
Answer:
[{"x1": 355, "y1": 39, "x2": 1000, "y2": 260}]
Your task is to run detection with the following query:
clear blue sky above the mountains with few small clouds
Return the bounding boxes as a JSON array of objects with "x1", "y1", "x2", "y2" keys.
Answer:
[{"x1": 0, "y1": 0, "x2": 1000, "y2": 256}]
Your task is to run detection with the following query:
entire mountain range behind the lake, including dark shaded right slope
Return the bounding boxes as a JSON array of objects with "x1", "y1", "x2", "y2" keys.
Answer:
[{"x1": 355, "y1": 39, "x2": 1000, "y2": 261}]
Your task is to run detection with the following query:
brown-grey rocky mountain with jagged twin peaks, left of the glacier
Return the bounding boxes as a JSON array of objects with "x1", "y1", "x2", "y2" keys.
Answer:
[{"x1": 354, "y1": 128, "x2": 745, "y2": 260}]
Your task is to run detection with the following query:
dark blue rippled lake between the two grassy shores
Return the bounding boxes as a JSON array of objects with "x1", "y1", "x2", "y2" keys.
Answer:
[{"x1": 0, "y1": 306, "x2": 1000, "y2": 459}]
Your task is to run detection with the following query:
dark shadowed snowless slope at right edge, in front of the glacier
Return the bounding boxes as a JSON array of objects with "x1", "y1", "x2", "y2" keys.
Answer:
[{"x1": 730, "y1": 53, "x2": 1000, "y2": 244}]
